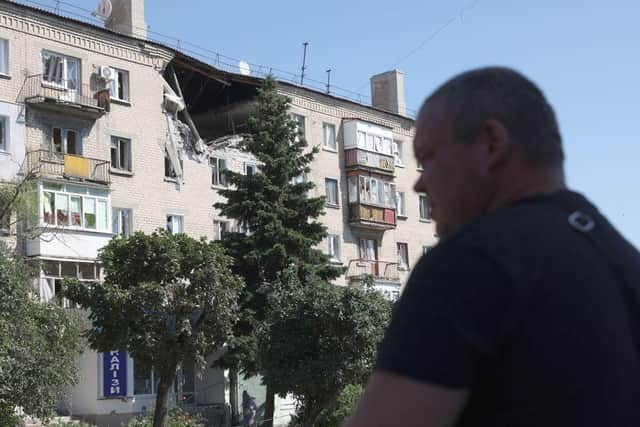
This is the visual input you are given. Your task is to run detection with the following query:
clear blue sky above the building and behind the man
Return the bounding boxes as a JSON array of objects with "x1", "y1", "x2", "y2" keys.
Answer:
[{"x1": 31, "y1": 0, "x2": 640, "y2": 247}]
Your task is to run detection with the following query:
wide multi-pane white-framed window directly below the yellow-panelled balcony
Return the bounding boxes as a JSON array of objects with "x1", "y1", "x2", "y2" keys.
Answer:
[{"x1": 41, "y1": 183, "x2": 109, "y2": 232}]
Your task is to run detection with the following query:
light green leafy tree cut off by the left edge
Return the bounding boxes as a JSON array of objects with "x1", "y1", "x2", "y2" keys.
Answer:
[{"x1": 0, "y1": 242, "x2": 83, "y2": 425}]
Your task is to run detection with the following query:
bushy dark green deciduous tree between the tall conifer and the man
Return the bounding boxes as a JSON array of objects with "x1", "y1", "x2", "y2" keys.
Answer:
[{"x1": 258, "y1": 275, "x2": 391, "y2": 427}]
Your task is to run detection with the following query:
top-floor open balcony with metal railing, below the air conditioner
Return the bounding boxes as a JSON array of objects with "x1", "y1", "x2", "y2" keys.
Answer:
[{"x1": 18, "y1": 74, "x2": 109, "y2": 120}]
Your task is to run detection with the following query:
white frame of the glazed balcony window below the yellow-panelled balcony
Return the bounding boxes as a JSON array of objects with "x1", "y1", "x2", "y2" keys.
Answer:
[{"x1": 39, "y1": 183, "x2": 112, "y2": 234}]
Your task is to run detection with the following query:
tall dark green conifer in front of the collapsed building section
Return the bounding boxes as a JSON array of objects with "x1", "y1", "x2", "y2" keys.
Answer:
[{"x1": 215, "y1": 77, "x2": 343, "y2": 425}]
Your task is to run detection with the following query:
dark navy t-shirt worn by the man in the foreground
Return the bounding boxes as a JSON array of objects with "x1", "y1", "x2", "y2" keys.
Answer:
[{"x1": 376, "y1": 191, "x2": 640, "y2": 427}]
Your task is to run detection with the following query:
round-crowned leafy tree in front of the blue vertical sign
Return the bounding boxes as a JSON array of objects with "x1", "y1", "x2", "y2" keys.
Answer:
[{"x1": 65, "y1": 230, "x2": 242, "y2": 427}]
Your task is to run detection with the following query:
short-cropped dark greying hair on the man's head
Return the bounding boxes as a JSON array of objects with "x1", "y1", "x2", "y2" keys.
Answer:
[{"x1": 425, "y1": 67, "x2": 564, "y2": 166}]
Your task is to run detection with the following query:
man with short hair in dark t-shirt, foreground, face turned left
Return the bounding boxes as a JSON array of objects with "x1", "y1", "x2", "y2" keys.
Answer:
[{"x1": 348, "y1": 67, "x2": 640, "y2": 427}]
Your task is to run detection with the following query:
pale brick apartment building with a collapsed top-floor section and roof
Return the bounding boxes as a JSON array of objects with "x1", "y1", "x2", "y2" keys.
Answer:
[{"x1": 0, "y1": 0, "x2": 436, "y2": 425}]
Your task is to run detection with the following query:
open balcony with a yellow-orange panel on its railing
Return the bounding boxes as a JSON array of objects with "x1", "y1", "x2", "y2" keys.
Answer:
[{"x1": 24, "y1": 150, "x2": 111, "y2": 185}]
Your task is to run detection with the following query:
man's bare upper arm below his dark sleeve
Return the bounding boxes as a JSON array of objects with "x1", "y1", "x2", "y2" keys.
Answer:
[{"x1": 344, "y1": 371, "x2": 468, "y2": 427}]
